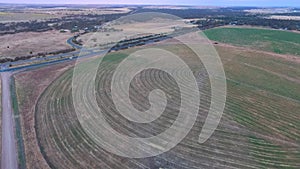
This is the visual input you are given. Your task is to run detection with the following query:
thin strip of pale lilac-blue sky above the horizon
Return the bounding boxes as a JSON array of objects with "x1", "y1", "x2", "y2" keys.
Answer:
[{"x1": 0, "y1": 0, "x2": 300, "y2": 7}]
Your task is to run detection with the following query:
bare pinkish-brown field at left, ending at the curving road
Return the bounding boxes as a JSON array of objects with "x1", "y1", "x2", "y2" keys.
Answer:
[{"x1": 0, "y1": 31, "x2": 73, "y2": 59}]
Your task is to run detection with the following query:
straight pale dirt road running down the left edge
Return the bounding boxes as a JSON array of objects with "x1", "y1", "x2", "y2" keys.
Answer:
[{"x1": 1, "y1": 72, "x2": 18, "y2": 169}]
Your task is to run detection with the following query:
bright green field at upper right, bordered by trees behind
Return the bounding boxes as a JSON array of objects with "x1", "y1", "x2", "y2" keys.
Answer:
[{"x1": 204, "y1": 28, "x2": 300, "y2": 55}]
